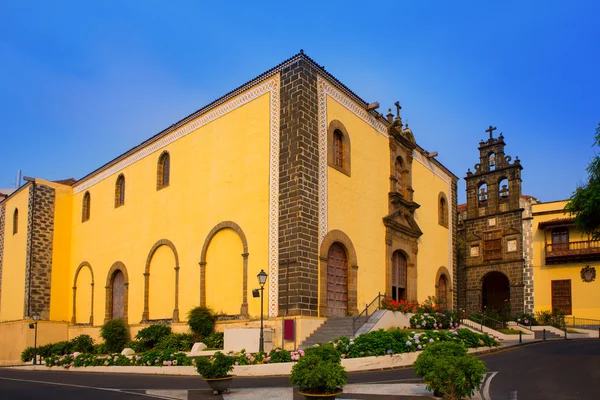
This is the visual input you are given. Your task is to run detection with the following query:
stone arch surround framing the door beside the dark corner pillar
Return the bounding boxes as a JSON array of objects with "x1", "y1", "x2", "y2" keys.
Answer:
[{"x1": 319, "y1": 229, "x2": 358, "y2": 317}]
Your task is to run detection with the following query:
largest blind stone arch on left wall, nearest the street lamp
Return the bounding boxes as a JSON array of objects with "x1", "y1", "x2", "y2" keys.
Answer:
[{"x1": 199, "y1": 221, "x2": 249, "y2": 316}]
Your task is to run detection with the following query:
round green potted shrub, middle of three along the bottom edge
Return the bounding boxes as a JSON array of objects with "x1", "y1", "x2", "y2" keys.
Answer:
[{"x1": 290, "y1": 346, "x2": 348, "y2": 400}]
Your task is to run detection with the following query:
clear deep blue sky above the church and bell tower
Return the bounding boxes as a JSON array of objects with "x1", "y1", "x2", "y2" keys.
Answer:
[{"x1": 0, "y1": 0, "x2": 600, "y2": 201}]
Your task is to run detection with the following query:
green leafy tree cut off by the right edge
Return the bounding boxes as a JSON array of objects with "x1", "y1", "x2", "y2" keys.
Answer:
[{"x1": 565, "y1": 123, "x2": 600, "y2": 240}]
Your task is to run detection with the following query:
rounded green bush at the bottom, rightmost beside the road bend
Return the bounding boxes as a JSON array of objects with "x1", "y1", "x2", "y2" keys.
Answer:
[{"x1": 414, "y1": 342, "x2": 486, "y2": 399}]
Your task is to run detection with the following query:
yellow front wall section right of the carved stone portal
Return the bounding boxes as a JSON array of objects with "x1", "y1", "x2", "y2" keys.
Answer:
[{"x1": 412, "y1": 158, "x2": 452, "y2": 302}]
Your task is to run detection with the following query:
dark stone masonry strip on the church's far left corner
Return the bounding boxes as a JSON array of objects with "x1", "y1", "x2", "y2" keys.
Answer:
[{"x1": 23, "y1": 184, "x2": 55, "y2": 320}]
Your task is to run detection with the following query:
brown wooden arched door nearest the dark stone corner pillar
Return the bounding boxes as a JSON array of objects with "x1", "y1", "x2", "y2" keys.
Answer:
[{"x1": 327, "y1": 243, "x2": 348, "y2": 317}]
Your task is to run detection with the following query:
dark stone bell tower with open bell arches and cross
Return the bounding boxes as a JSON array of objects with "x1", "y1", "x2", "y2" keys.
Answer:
[{"x1": 458, "y1": 126, "x2": 525, "y2": 314}]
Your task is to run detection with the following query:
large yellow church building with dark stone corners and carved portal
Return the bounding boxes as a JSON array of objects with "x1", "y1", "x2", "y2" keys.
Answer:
[{"x1": 0, "y1": 52, "x2": 458, "y2": 360}]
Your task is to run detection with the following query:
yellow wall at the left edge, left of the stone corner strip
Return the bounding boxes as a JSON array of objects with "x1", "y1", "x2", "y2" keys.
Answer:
[{"x1": 0, "y1": 184, "x2": 31, "y2": 321}]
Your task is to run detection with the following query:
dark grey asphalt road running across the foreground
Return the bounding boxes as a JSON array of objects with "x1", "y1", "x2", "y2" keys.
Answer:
[{"x1": 0, "y1": 340, "x2": 600, "y2": 400}]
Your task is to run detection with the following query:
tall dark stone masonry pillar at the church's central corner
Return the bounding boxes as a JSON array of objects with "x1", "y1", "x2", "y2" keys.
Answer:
[{"x1": 279, "y1": 59, "x2": 319, "y2": 316}]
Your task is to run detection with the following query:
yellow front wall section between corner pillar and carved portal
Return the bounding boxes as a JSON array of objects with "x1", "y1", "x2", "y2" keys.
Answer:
[{"x1": 320, "y1": 97, "x2": 390, "y2": 310}]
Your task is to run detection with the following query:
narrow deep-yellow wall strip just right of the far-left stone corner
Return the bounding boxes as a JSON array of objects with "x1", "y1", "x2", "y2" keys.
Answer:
[{"x1": 44, "y1": 179, "x2": 73, "y2": 322}]
